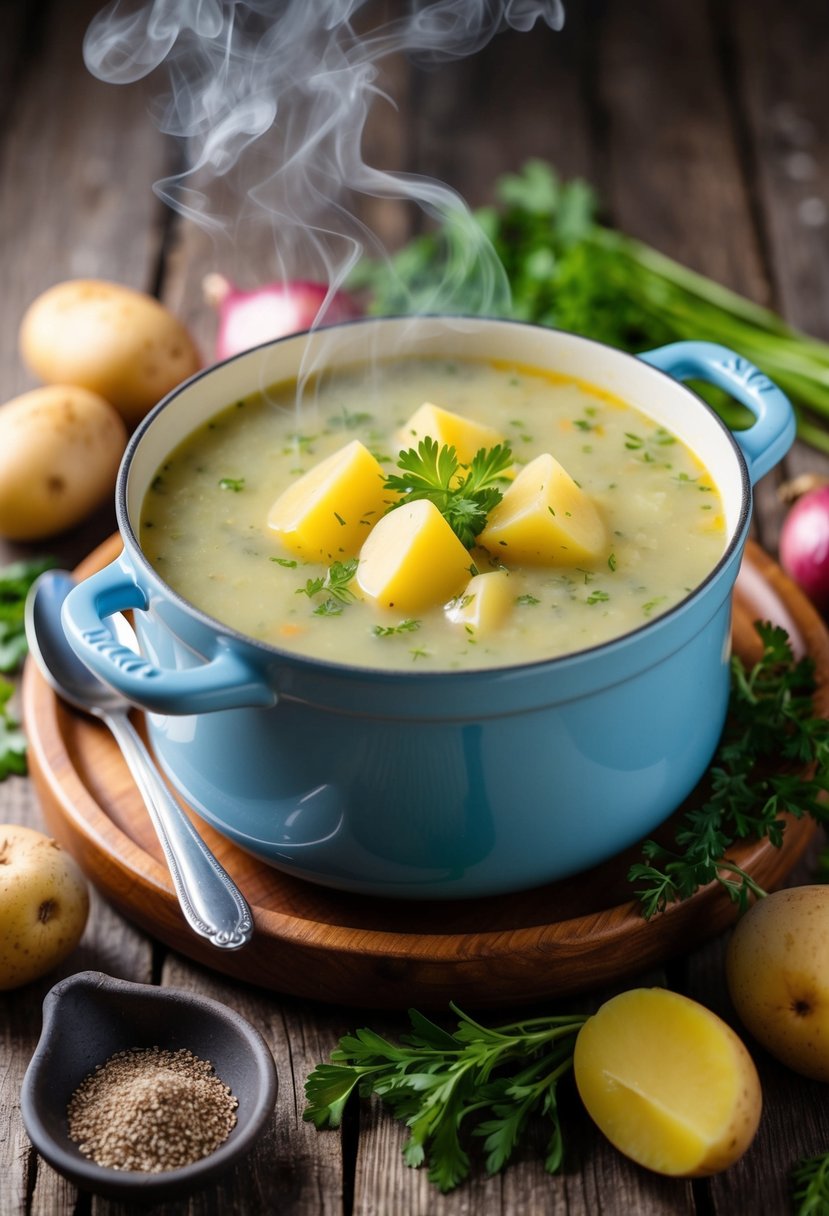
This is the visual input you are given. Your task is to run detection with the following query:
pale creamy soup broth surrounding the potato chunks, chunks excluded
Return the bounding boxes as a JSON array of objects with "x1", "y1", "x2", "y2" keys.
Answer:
[{"x1": 140, "y1": 359, "x2": 726, "y2": 670}]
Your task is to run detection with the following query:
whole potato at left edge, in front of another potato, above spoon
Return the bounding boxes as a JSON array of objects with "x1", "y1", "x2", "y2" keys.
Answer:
[{"x1": 0, "y1": 384, "x2": 126, "y2": 540}]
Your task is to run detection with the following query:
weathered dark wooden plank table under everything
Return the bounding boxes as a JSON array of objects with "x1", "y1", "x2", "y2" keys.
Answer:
[{"x1": 0, "y1": 0, "x2": 829, "y2": 1216}]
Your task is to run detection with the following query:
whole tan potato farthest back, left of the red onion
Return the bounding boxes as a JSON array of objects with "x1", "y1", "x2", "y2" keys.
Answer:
[{"x1": 19, "y1": 278, "x2": 201, "y2": 427}]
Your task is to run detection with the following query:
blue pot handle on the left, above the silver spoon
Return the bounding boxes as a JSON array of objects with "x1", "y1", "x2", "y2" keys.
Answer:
[{"x1": 61, "y1": 558, "x2": 277, "y2": 714}]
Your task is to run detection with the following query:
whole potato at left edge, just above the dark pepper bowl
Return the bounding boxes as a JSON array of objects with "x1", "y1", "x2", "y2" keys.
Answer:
[{"x1": 0, "y1": 823, "x2": 89, "y2": 991}]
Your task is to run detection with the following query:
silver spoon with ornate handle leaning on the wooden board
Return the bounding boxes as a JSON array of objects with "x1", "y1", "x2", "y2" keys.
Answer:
[{"x1": 26, "y1": 570, "x2": 253, "y2": 950}]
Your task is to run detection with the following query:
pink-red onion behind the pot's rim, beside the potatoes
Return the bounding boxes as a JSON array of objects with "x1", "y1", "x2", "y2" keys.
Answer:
[{"x1": 202, "y1": 275, "x2": 360, "y2": 359}]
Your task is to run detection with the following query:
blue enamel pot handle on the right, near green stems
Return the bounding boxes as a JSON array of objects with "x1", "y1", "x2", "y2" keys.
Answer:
[{"x1": 639, "y1": 342, "x2": 795, "y2": 485}]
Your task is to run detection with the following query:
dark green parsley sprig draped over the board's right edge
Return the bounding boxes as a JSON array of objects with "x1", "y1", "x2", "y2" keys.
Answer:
[{"x1": 628, "y1": 623, "x2": 829, "y2": 918}]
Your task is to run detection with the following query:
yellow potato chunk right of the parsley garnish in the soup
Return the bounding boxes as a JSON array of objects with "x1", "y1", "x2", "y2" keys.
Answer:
[{"x1": 478, "y1": 452, "x2": 608, "y2": 565}]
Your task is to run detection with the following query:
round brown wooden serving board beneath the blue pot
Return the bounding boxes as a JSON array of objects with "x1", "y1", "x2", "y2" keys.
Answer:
[{"x1": 23, "y1": 536, "x2": 829, "y2": 1008}]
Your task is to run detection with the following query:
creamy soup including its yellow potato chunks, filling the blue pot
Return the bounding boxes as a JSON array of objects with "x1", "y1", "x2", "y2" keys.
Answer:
[{"x1": 140, "y1": 359, "x2": 726, "y2": 670}]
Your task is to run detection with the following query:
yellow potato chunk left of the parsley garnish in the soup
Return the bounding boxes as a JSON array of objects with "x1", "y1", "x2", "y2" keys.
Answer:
[{"x1": 267, "y1": 439, "x2": 389, "y2": 561}]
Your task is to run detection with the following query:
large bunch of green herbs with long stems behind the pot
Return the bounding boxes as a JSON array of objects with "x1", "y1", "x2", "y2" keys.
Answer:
[{"x1": 351, "y1": 159, "x2": 829, "y2": 451}]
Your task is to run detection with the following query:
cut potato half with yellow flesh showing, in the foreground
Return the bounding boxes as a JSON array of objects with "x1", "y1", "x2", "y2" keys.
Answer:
[{"x1": 574, "y1": 987, "x2": 762, "y2": 1177}]
